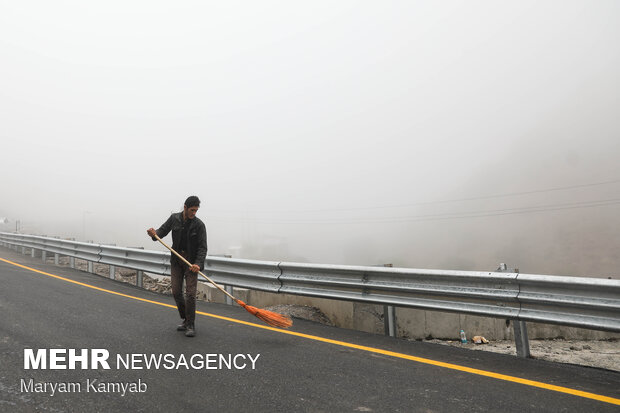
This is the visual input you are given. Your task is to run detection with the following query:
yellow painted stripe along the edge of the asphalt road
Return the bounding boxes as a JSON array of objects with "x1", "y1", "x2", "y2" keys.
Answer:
[{"x1": 0, "y1": 258, "x2": 620, "y2": 405}]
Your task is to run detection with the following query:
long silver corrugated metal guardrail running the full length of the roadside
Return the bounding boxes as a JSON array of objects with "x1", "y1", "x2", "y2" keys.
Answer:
[{"x1": 0, "y1": 232, "x2": 620, "y2": 356}]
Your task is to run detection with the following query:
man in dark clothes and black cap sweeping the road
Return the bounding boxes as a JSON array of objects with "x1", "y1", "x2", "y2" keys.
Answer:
[{"x1": 146, "y1": 196, "x2": 207, "y2": 337}]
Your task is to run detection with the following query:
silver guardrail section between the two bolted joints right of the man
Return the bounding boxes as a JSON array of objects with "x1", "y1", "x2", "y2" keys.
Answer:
[{"x1": 280, "y1": 262, "x2": 519, "y2": 318}]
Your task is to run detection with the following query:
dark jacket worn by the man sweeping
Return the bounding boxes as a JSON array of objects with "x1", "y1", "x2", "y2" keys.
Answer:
[{"x1": 153, "y1": 212, "x2": 207, "y2": 271}]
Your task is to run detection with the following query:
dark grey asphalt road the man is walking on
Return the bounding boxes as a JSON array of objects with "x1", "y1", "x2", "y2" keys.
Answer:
[{"x1": 0, "y1": 248, "x2": 620, "y2": 413}]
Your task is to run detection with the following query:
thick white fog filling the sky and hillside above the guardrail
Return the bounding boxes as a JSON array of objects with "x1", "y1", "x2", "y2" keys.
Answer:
[{"x1": 0, "y1": 1, "x2": 620, "y2": 278}]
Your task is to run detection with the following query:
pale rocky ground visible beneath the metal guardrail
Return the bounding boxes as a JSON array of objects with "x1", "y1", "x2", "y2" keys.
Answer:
[{"x1": 54, "y1": 257, "x2": 620, "y2": 371}]
